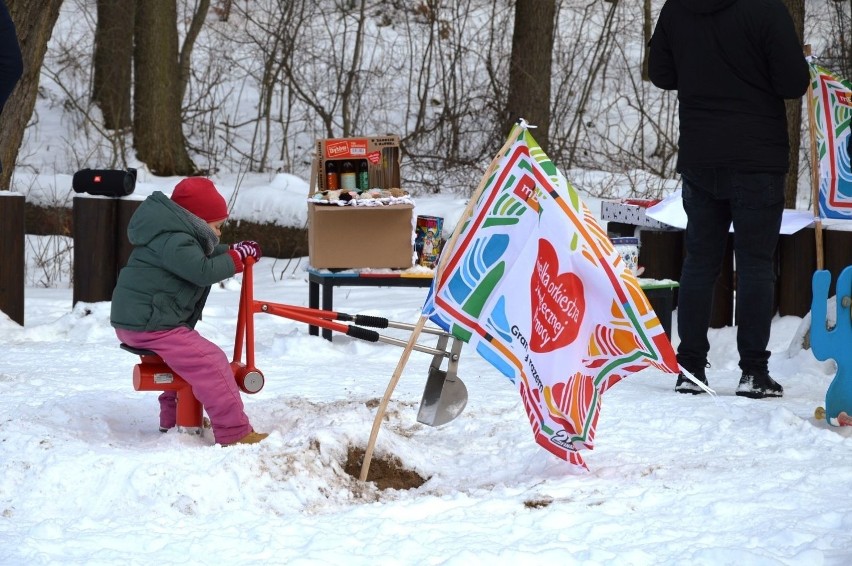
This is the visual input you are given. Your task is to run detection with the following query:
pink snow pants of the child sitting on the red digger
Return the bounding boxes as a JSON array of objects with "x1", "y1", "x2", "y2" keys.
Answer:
[{"x1": 115, "y1": 326, "x2": 252, "y2": 444}]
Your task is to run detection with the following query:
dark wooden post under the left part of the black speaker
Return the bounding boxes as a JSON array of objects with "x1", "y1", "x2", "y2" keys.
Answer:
[{"x1": 72, "y1": 195, "x2": 117, "y2": 304}]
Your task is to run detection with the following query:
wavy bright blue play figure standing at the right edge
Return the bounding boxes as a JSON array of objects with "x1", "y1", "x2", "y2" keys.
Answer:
[{"x1": 811, "y1": 266, "x2": 852, "y2": 426}]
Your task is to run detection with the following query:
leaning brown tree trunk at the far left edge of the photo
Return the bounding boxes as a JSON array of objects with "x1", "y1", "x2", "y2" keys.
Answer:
[{"x1": 0, "y1": 0, "x2": 62, "y2": 190}]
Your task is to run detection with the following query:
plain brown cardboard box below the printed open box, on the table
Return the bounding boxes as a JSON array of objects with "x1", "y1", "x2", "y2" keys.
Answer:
[{"x1": 308, "y1": 203, "x2": 414, "y2": 269}]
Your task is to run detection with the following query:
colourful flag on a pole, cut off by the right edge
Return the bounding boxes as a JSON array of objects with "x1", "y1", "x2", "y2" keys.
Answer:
[{"x1": 810, "y1": 64, "x2": 852, "y2": 219}]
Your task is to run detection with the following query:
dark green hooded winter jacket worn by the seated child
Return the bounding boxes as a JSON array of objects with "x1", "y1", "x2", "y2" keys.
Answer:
[{"x1": 110, "y1": 191, "x2": 236, "y2": 332}]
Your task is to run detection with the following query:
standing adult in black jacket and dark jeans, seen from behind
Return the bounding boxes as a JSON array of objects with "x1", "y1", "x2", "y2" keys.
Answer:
[{"x1": 649, "y1": 0, "x2": 810, "y2": 398}]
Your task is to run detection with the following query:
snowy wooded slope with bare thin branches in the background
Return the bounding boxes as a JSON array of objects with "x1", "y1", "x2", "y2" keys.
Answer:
[{"x1": 0, "y1": 0, "x2": 852, "y2": 202}]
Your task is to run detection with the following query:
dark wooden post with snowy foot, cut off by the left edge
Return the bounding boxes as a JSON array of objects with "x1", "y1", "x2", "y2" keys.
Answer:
[{"x1": 0, "y1": 191, "x2": 26, "y2": 326}]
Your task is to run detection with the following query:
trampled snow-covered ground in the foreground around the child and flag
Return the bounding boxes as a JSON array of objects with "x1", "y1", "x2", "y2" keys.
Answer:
[{"x1": 0, "y1": 236, "x2": 852, "y2": 565}]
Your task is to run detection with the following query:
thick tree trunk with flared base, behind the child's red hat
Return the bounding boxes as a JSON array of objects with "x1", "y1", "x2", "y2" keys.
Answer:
[{"x1": 133, "y1": 0, "x2": 198, "y2": 176}]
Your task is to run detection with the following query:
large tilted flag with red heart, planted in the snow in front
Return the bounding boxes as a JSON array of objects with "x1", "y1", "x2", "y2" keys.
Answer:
[{"x1": 423, "y1": 126, "x2": 678, "y2": 467}]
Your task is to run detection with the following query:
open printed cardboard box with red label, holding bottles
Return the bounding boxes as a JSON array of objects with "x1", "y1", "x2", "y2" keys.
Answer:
[{"x1": 311, "y1": 135, "x2": 400, "y2": 194}]
